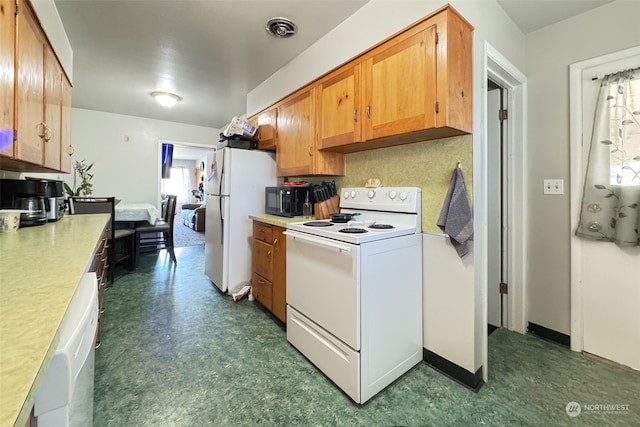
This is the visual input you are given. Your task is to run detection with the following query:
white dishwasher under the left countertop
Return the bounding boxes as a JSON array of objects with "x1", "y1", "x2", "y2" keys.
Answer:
[{"x1": 34, "y1": 273, "x2": 98, "y2": 427}]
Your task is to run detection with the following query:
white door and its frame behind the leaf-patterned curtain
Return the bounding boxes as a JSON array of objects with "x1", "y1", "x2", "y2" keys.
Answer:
[{"x1": 570, "y1": 47, "x2": 640, "y2": 370}]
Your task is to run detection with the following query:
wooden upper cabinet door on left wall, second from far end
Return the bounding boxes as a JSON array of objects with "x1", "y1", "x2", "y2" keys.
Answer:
[{"x1": 43, "y1": 46, "x2": 62, "y2": 170}]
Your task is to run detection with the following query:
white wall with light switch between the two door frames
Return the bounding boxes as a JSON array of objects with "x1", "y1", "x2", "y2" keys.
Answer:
[{"x1": 526, "y1": 0, "x2": 640, "y2": 335}]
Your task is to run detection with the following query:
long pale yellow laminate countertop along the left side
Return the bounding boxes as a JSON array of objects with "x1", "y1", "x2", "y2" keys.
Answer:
[{"x1": 0, "y1": 214, "x2": 109, "y2": 427}]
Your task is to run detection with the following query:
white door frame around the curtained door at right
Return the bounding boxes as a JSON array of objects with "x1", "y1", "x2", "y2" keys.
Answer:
[{"x1": 569, "y1": 46, "x2": 640, "y2": 351}]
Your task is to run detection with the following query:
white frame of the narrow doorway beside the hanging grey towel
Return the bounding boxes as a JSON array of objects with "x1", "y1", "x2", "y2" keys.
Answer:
[{"x1": 473, "y1": 41, "x2": 527, "y2": 382}]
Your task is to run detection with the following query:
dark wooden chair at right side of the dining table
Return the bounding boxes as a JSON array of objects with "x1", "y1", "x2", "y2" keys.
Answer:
[{"x1": 135, "y1": 195, "x2": 178, "y2": 264}]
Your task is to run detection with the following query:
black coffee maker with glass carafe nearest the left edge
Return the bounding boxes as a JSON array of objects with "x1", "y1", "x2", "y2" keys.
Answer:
[{"x1": 0, "y1": 179, "x2": 49, "y2": 227}]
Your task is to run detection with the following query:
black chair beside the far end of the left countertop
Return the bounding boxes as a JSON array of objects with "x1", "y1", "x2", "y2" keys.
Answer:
[{"x1": 69, "y1": 196, "x2": 136, "y2": 283}]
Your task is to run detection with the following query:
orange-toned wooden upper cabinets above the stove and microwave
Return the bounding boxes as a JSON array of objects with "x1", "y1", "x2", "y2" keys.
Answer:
[{"x1": 251, "y1": 5, "x2": 473, "y2": 160}]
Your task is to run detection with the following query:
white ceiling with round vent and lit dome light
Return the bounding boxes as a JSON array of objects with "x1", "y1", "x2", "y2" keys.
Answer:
[{"x1": 55, "y1": 0, "x2": 613, "y2": 128}]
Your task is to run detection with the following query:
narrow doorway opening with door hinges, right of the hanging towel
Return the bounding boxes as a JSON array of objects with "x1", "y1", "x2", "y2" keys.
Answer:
[{"x1": 487, "y1": 79, "x2": 509, "y2": 334}]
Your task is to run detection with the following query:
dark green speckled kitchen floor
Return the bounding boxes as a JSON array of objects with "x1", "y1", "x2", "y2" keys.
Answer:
[{"x1": 94, "y1": 246, "x2": 640, "y2": 427}]
